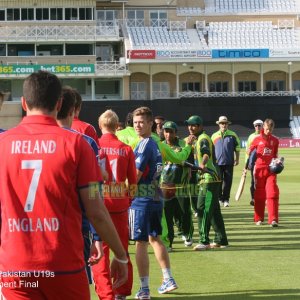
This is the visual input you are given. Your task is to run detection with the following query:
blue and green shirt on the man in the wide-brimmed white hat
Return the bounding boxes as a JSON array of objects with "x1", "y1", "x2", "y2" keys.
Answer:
[{"x1": 211, "y1": 129, "x2": 241, "y2": 166}]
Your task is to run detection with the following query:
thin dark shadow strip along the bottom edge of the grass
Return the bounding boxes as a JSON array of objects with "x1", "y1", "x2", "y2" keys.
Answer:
[{"x1": 151, "y1": 289, "x2": 300, "y2": 300}]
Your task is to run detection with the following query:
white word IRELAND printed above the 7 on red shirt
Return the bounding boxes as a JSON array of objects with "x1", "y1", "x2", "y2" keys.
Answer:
[{"x1": 11, "y1": 140, "x2": 56, "y2": 154}]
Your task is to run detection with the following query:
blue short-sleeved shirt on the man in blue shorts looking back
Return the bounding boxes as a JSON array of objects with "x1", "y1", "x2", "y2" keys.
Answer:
[{"x1": 132, "y1": 137, "x2": 162, "y2": 207}]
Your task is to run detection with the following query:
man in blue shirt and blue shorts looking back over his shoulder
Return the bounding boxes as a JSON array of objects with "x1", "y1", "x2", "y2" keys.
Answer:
[{"x1": 129, "y1": 107, "x2": 178, "y2": 299}]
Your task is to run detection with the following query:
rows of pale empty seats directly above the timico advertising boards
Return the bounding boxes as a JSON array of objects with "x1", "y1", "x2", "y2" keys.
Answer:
[{"x1": 127, "y1": 21, "x2": 300, "y2": 50}]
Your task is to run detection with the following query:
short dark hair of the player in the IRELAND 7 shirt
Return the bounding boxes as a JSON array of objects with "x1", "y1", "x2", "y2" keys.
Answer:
[{"x1": 23, "y1": 71, "x2": 62, "y2": 111}]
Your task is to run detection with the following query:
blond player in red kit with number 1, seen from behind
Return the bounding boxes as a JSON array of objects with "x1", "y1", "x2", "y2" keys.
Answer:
[{"x1": 92, "y1": 110, "x2": 137, "y2": 300}]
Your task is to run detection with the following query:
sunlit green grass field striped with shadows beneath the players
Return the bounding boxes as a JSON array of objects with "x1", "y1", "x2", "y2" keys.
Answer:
[{"x1": 92, "y1": 149, "x2": 300, "y2": 300}]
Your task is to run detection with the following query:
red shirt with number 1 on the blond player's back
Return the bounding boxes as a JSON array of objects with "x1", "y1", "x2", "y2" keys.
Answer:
[{"x1": 99, "y1": 133, "x2": 137, "y2": 212}]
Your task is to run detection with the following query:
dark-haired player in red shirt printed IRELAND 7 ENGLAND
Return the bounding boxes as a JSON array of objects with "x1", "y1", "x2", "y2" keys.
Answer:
[{"x1": 0, "y1": 71, "x2": 127, "y2": 300}]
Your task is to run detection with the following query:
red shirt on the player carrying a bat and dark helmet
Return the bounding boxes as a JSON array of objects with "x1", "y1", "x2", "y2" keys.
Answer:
[{"x1": 249, "y1": 132, "x2": 279, "y2": 166}]
